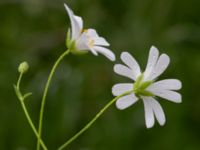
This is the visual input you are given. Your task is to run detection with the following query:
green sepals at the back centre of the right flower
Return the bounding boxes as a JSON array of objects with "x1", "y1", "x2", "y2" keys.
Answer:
[{"x1": 133, "y1": 74, "x2": 153, "y2": 97}]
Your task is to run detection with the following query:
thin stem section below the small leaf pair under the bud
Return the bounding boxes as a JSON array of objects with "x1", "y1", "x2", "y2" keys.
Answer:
[{"x1": 20, "y1": 100, "x2": 47, "y2": 150}]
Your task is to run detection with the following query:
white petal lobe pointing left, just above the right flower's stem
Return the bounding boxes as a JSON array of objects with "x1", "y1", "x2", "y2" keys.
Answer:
[{"x1": 112, "y1": 83, "x2": 133, "y2": 96}]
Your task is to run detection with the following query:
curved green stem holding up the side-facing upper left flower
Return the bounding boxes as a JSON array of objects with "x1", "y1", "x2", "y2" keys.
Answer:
[{"x1": 37, "y1": 49, "x2": 70, "y2": 150}]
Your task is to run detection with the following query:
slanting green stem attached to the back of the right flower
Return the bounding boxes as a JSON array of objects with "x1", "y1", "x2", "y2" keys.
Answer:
[{"x1": 58, "y1": 91, "x2": 132, "y2": 150}]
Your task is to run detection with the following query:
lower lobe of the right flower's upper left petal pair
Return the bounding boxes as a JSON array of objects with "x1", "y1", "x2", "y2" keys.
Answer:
[{"x1": 114, "y1": 64, "x2": 135, "y2": 80}]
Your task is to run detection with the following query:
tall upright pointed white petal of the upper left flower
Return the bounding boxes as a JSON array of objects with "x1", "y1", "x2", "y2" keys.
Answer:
[{"x1": 64, "y1": 4, "x2": 82, "y2": 40}]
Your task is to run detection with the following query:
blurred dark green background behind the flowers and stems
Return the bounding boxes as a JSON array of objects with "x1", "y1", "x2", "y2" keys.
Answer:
[{"x1": 0, "y1": 0, "x2": 200, "y2": 150}]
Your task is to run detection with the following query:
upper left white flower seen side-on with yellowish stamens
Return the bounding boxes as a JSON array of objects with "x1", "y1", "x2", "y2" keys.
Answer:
[{"x1": 64, "y1": 4, "x2": 115, "y2": 61}]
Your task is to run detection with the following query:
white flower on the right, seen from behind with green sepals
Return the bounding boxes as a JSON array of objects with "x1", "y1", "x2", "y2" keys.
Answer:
[{"x1": 112, "y1": 46, "x2": 182, "y2": 128}]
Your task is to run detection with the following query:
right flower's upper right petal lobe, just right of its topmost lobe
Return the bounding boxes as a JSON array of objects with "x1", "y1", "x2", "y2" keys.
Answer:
[{"x1": 151, "y1": 54, "x2": 170, "y2": 80}]
